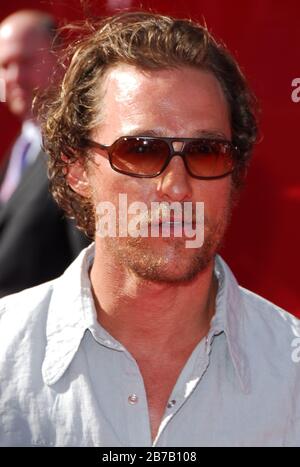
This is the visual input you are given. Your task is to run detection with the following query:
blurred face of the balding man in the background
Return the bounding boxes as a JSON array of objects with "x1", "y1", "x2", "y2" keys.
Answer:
[{"x1": 0, "y1": 20, "x2": 54, "y2": 120}]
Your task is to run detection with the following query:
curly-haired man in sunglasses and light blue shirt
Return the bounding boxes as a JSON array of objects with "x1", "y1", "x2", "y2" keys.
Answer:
[{"x1": 0, "y1": 13, "x2": 300, "y2": 447}]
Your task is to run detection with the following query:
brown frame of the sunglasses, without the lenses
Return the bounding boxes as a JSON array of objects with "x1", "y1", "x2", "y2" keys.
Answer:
[{"x1": 85, "y1": 136, "x2": 239, "y2": 180}]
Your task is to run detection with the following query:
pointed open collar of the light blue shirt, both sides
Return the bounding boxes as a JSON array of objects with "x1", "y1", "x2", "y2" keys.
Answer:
[{"x1": 42, "y1": 244, "x2": 250, "y2": 392}]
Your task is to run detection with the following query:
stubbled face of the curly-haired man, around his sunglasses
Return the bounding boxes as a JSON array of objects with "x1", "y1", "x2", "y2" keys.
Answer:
[{"x1": 81, "y1": 65, "x2": 232, "y2": 283}]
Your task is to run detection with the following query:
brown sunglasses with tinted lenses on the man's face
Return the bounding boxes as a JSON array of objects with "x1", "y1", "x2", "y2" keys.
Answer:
[{"x1": 85, "y1": 136, "x2": 238, "y2": 180}]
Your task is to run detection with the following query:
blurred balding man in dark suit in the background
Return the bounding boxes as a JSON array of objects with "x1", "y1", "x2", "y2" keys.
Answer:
[{"x1": 0, "y1": 10, "x2": 88, "y2": 296}]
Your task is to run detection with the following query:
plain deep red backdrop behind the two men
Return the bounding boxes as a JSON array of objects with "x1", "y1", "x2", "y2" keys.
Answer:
[{"x1": 0, "y1": 0, "x2": 300, "y2": 316}]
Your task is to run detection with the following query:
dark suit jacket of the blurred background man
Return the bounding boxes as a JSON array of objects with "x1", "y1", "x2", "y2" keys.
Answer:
[{"x1": 0, "y1": 152, "x2": 89, "y2": 297}]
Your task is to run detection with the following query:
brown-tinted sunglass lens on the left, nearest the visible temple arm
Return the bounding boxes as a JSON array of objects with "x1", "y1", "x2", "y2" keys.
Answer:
[{"x1": 110, "y1": 138, "x2": 169, "y2": 176}]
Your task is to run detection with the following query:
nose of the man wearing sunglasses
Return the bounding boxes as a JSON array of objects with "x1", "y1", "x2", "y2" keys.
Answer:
[{"x1": 157, "y1": 156, "x2": 192, "y2": 202}]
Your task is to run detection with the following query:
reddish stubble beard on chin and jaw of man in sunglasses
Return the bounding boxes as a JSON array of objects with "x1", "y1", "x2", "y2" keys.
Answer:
[{"x1": 104, "y1": 203, "x2": 232, "y2": 284}]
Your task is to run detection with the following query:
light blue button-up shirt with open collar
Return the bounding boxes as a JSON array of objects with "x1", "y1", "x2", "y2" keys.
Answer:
[{"x1": 0, "y1": 245, "x2": 300, "y2": 447}]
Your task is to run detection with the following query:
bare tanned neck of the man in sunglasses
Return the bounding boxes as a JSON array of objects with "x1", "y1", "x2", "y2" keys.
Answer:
[{"x1": 91, "y1": 241, "x2": 217, "y2": 356}]
